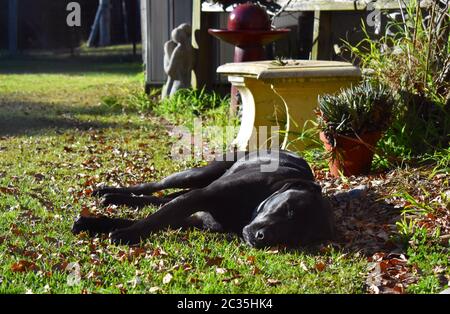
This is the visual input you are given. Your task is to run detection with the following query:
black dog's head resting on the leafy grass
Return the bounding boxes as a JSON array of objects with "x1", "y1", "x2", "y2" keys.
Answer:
[{"x1": 242, "y1": 181, "x2": 334, "y2": 248}]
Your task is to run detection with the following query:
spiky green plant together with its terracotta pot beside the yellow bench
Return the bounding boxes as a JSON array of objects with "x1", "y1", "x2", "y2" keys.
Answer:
[{"x1": 318, "y1": 81, "x2": 394, "y2": 177}]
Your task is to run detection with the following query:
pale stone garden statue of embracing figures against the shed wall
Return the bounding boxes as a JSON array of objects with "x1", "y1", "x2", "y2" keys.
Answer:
[{"x1": 161, "y1": 23, "x2": 194, "y2": 98}]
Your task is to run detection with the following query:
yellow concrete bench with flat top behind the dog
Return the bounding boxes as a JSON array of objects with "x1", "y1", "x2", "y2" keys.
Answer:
[{"x1": 217, "y1": 60, "x2": 361, "y2": 150}]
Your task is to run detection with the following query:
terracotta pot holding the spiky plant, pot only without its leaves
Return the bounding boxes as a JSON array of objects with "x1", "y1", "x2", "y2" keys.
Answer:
[{"x1": 320, "y1": 132, "x2": 381, "y2": 177}]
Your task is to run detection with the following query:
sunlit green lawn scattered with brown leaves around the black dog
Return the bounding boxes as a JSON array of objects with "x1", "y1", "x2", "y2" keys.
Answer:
[{"x1": 0, "y1": 50, "x2": 446, "y2": 293}]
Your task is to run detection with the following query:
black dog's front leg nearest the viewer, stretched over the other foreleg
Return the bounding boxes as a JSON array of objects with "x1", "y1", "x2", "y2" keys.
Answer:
[{"x1": 111, "y1": 189, "x2": 211, "y2": 244}]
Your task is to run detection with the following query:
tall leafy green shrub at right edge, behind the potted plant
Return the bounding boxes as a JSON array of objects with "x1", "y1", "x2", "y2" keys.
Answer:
[{"x1": 346, "y1": 1, "x2": 450, "y2": 159}]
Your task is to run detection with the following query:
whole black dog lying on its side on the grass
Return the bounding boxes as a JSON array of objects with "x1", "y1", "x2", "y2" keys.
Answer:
[{"x1": 72, "y1": 151, "x2": 334, "y2": 247}]
